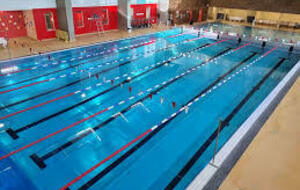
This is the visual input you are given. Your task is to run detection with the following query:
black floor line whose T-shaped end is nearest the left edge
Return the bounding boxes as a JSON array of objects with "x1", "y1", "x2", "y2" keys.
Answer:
[{"x1": 6, "y1": 44, "x2": 211, "y2": 139}]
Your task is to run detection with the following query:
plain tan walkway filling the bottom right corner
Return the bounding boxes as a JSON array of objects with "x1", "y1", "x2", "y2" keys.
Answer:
[{"x1": 219, "y1": 77, "x2": 300, "y2": 190}]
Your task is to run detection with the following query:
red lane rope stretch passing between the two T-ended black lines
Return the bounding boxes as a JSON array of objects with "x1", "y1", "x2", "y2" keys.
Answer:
[{"x1": 0, "y1": 108, "x2": 108, "y2": 161}]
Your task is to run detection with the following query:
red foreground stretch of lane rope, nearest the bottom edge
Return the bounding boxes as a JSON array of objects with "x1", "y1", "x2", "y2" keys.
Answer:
[{"x1": 60, "y1": 129, "x2": 152, "y2": 190}]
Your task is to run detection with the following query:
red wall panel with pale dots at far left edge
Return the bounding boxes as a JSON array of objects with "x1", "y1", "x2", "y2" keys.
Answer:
[{"x1": 0, "y1": 11, "x2": 27, "y2": 38}]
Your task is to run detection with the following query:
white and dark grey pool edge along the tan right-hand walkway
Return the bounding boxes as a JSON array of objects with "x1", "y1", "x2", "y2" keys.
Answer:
[{"x1": 186, "y1": 58, "x2": 300, "y2": 190}]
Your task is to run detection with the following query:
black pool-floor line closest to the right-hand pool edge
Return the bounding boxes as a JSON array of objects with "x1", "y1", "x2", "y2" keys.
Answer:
[{"x1": 165, "y1": 58, "x2": 285, "y2": 190}]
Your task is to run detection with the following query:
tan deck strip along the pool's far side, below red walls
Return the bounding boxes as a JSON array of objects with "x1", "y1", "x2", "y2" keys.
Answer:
[{"x1": 0, "y1": 25, "x2": 170, "y2": 61}]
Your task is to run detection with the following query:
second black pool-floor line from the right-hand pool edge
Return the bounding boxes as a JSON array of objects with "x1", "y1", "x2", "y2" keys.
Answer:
[{"x1": 74, "y1": 52, "x2": 257, "y2": 190}]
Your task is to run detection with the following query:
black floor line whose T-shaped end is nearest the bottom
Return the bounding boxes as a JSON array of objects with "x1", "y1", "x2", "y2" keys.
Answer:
[{"x1": 30, "y1": 48, "x2": 237, "y2": 169}]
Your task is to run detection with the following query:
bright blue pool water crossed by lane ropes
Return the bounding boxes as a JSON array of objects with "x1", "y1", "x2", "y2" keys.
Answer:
[{"x1": 0, "y1": 25, "x2": 300, "y2": 190}]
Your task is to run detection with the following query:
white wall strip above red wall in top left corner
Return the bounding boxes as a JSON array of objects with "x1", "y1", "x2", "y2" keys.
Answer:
[{"x1": 0, "y1": 0, "x2": 56, "y2": 11}]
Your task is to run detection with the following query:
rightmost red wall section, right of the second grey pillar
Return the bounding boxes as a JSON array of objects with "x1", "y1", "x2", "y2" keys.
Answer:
[{"x1": 130, "y1": 4, "x2": 157, "y2": 24}]
